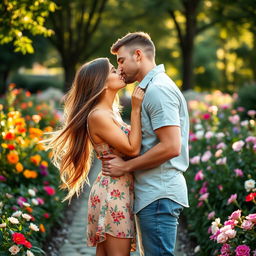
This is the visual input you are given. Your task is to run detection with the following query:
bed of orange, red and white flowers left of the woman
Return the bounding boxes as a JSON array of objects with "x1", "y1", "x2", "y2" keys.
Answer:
[{"x1": 0, "y1": 86, "x2": 65, "y2": 256}]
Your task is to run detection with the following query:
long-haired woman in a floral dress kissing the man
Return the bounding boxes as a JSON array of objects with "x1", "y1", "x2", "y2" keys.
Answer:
[{"x1": 45, "y1": 58, "x2": 144, "y2": 256}]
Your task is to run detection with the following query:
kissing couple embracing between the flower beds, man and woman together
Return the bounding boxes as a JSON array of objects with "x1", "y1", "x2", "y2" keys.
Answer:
[{"x1": 49, "y1": 32, "x2": 189, "y2": 256}]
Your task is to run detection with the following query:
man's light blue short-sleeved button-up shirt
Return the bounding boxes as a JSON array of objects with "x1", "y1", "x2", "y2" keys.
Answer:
[{"x1": 134, "y1": 64, "x2": 189, "y2": 213}]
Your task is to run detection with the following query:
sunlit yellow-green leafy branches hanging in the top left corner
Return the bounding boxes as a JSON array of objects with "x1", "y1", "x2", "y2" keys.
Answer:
[{"x1": 0, "y1": 0, "x2": 56, "y2": 54}]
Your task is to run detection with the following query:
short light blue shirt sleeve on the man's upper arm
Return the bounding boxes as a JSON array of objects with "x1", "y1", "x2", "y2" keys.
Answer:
[{"x1": 146, "y1": 85, "x2": 180, "y2": 130}]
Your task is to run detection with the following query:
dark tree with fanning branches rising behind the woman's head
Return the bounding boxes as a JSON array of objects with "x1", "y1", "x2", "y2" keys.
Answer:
[{"x1": 49, "y1": 0, "x2": 107, "y2": 91}]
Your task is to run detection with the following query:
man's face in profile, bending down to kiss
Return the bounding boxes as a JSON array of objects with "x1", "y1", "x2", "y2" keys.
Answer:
[{"x1": 117, "y1": 46, "x2": 139, "y2": 84}]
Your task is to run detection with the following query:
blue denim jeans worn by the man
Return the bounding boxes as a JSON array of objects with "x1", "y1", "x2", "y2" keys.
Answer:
[{"x1": 137, "y1": 198, "x2": 183, "y2": 256}]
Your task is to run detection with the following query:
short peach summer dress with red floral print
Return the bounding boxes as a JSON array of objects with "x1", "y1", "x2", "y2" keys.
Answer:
[{"x1": 87, "y1": 112, "x2": 136, "y2": 251}]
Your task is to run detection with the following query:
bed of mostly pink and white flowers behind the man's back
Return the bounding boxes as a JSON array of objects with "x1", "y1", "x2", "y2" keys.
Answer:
[{"x1": 184, "y1": 92, "x2": 256, "y2": 256}]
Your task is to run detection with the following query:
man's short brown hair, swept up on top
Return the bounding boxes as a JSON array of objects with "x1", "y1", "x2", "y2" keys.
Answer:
[{"x1": 110, "y1": 32, "x2": 155, "y2": 57}]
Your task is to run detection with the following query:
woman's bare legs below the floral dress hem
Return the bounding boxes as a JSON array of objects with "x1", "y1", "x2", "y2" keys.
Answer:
[{"x1": 103, "y1": 234, "x2": 131, "y2": 256}]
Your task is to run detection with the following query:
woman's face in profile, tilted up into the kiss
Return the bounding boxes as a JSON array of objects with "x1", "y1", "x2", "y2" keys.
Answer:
[{"x1": 106, "y1": 63, "x2": 126, "y2": 90}]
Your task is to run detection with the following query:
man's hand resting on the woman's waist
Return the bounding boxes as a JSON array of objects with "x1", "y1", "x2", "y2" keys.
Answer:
[{"x1": 101, "y1": 155, "x2": 126, "y2": 177}]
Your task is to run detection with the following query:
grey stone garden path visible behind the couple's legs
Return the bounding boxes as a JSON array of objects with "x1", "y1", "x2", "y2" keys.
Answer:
[{"x1": 59, "y1": 159, "x2": 185, "y2": 256}]
